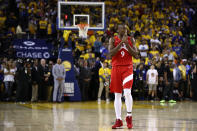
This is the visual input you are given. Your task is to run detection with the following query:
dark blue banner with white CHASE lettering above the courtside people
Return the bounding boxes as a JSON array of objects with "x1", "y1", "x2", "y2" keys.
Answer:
[{"x1": 13, "y1": 39, "x2": 53, "y2": 59}]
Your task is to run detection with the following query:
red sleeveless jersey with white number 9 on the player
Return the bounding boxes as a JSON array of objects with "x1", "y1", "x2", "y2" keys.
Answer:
[{"x1": 112, "y1": 36, "x2": 133, "y2": 66}]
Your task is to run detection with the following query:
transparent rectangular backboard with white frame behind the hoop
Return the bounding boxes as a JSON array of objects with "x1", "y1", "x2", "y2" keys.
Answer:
[{"x1": 57, "y1": 1, "x2": 105, "y2": 30}]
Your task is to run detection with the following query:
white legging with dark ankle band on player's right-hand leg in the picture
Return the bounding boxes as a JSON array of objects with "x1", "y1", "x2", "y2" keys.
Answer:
[{"x1": 124, "y1": 89, "x2": 133, "y2": 116}]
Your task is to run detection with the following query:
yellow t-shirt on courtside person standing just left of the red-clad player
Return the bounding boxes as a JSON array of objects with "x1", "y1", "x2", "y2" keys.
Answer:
[{"x1": 99, "y1": 67, "x2": 111, "y2": 82}]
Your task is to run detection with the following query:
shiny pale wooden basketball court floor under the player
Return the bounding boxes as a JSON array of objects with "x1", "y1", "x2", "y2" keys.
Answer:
[{"x1": 0, "y1": 101, "x2": 197, "y2": 131}]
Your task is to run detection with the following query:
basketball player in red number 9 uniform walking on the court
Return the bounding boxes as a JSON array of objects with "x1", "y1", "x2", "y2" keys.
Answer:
[{"x1": 109, "y1": 24, "x2": 138, "y2": 129}]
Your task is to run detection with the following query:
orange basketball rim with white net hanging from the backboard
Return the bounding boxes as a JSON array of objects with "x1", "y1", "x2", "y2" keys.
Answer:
[{"x1": 77, "y1": 24, "x2": 89, "y2": 39}]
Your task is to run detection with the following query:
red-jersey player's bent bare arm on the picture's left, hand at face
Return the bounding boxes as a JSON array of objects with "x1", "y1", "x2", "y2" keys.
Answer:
[{"x1": 108, "y1": 37, "x2": 123, "y2": 56}]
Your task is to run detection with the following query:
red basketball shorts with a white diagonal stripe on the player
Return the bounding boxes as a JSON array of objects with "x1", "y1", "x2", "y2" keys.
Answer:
[{"x1": 110, "y1": 65, "x2": 133, "y2": 93}]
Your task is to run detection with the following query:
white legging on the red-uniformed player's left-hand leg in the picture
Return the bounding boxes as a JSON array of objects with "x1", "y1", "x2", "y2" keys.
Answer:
[{"x1": 114, "y1": 93, "x2": 122, "y2": 120}]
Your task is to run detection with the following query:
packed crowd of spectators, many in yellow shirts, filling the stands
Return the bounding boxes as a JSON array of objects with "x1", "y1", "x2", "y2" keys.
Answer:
[{"x1": 0, "y1": 0, "x2": 197, "y2": 102}]
